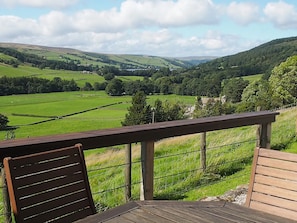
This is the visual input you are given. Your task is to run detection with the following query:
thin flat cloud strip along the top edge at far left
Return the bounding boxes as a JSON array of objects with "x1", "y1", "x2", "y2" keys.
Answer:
[{"x1": 0, "y1": 0, "x2": 78, "y2": 9}]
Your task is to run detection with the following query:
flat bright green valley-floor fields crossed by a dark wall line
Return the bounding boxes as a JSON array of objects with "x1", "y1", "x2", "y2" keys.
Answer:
[{"x1": 0, "y1": 91, "x2": 195, "y2": 139}]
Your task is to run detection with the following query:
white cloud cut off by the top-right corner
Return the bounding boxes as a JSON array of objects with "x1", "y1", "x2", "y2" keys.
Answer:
[{"x1": 264, "y1": 1, "x2": 297, "y2": 29}]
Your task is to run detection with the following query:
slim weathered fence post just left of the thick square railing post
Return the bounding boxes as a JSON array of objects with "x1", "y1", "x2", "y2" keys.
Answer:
[{"x1": 125, "y1": 144, "x2": 132, "y2": 202}]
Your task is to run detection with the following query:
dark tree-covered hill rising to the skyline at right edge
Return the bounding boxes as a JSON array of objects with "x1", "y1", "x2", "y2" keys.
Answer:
[{"x1": 195, "y1": 37, "x2": 297, "y2": 78}]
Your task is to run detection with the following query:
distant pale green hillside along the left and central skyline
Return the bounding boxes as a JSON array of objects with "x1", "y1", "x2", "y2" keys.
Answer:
[{"x1": 0, "y1": 43, "x2": 197, "y2": 69}]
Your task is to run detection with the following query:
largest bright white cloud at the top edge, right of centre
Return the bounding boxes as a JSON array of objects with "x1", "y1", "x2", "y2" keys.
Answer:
[{"x1": 120, "y1": 0, "x2": 218, "y2": 27}]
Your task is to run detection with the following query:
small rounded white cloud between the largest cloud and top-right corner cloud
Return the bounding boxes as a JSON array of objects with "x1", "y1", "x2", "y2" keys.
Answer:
[{"x1": 227, "y1": 2, "x2": 260, "y2": 25}]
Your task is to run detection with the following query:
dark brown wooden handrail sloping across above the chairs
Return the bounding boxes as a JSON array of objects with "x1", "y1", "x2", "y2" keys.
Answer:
[{"x1": 0, "y1": 111, "x2": 279, "y2": 161}]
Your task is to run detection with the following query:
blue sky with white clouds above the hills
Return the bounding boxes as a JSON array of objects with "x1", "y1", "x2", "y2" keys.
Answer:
[{"x1": 0, "y1": 0, "x2": 297, "y2": 57}]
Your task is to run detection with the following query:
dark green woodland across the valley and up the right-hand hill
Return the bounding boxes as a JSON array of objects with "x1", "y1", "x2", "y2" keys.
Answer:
[{"x1": 0, "y1": 37, "x2": 297, "y2": 126}]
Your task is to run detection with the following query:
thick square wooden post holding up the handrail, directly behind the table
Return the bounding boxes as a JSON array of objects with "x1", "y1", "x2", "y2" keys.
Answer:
[{"x1": 140, "y1": 141, "x2": 154, "y2": 200}]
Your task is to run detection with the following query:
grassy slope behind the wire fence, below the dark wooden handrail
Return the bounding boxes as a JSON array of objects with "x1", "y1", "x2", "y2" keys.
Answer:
[{"x1": 86, "y1": 108, "x2": 297, "y2": 206}]
